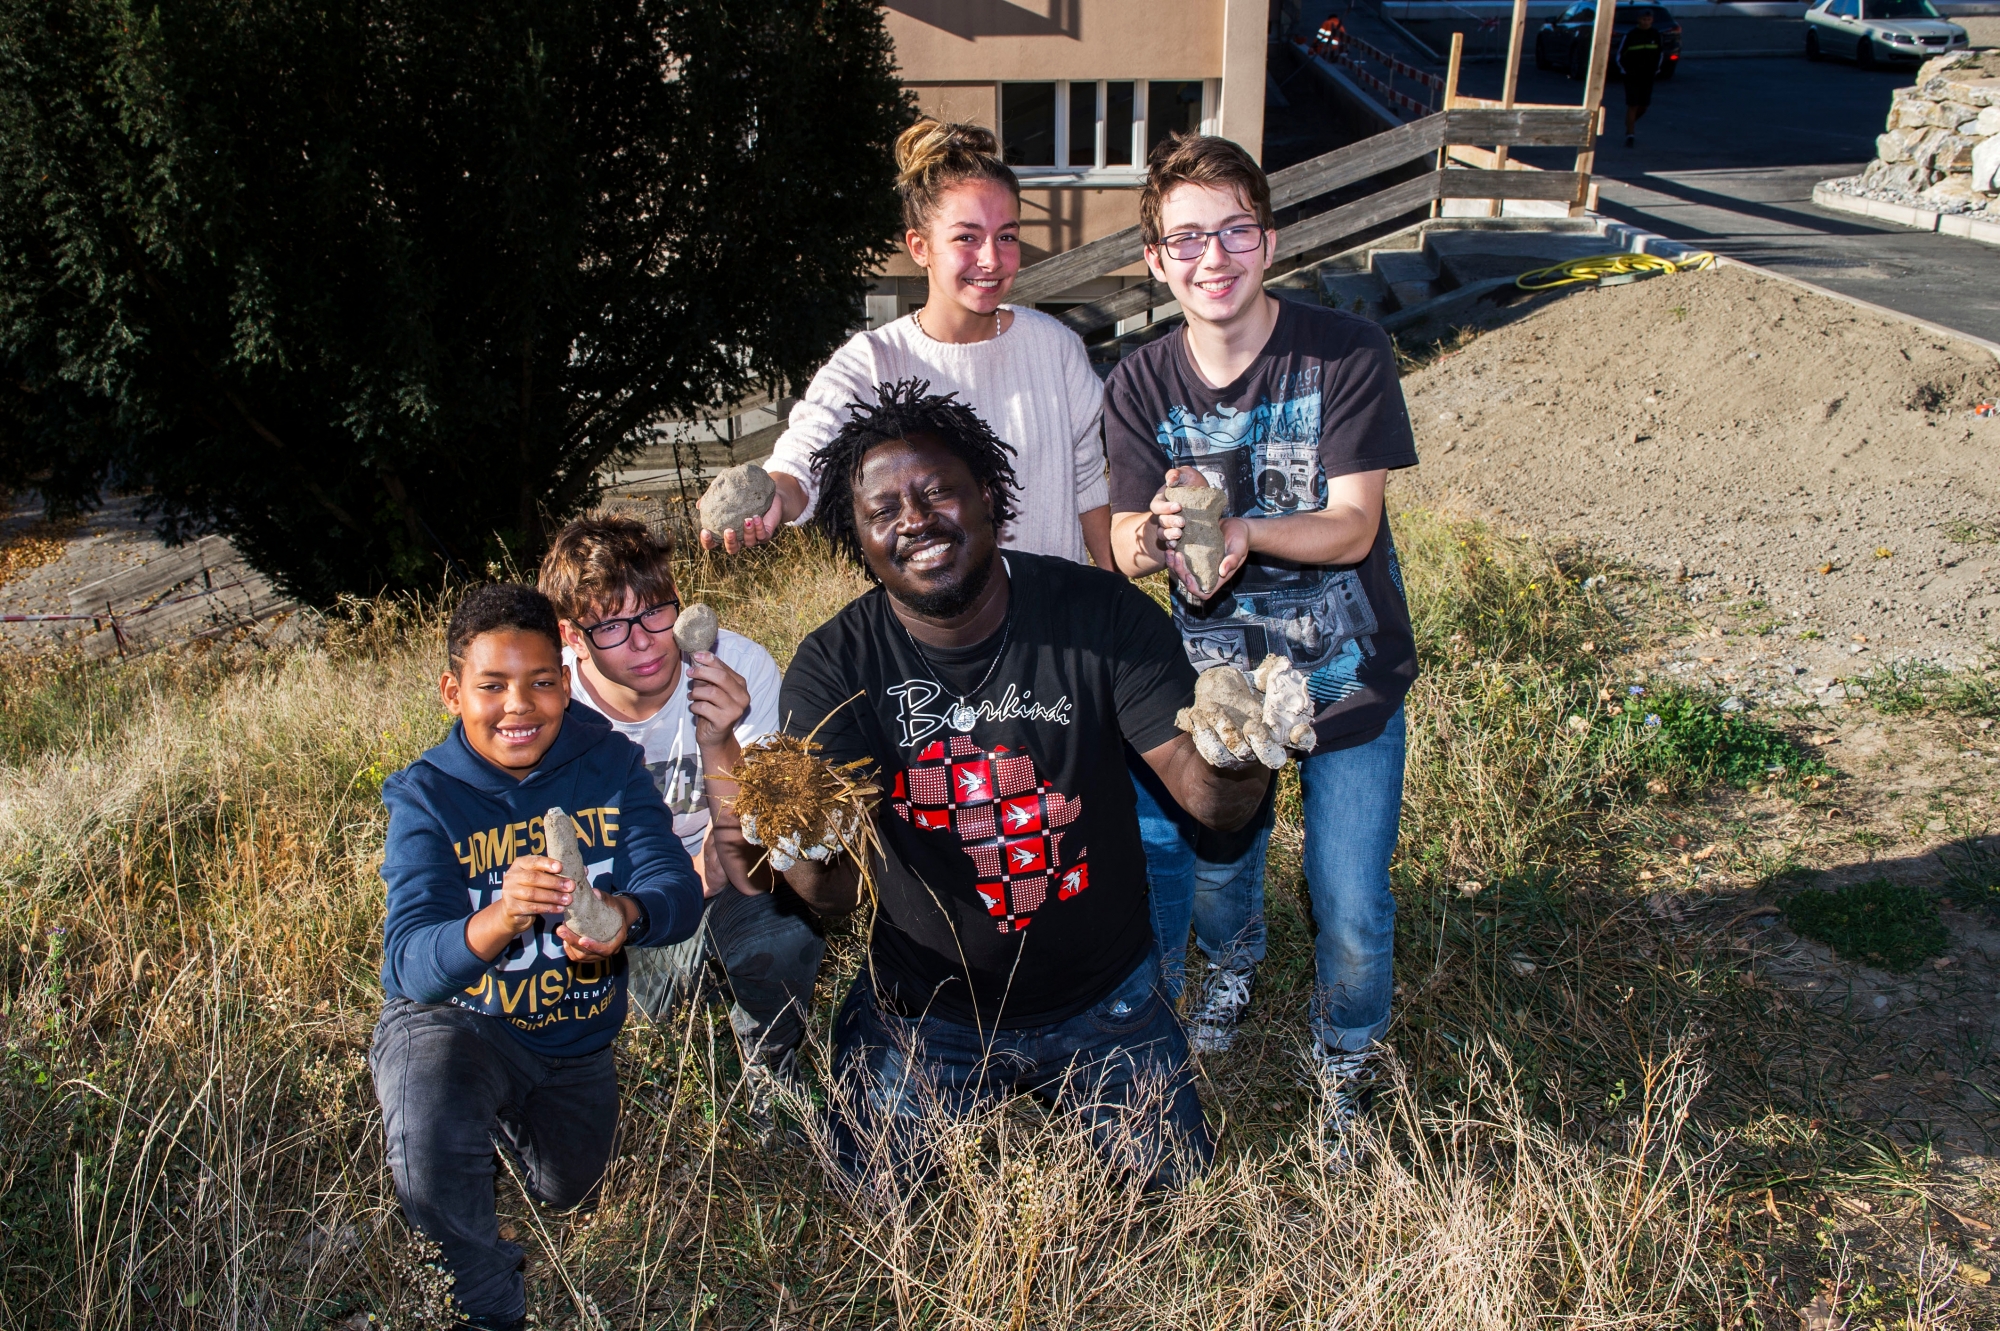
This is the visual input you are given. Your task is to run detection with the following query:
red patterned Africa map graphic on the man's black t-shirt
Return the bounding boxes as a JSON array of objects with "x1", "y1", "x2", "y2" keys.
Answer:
[{"x1": 890, "y1": 735, "x2": 1090, "y2": 933}]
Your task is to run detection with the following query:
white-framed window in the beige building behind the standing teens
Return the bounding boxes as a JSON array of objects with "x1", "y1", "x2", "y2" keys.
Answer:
[{"x1": 1000, "y1": 78, "x2": 1216, "y2": 174}]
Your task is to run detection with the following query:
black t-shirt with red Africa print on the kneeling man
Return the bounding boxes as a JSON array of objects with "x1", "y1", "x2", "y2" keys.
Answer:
[{"x1": 778, "y1": 550, "x2": 1194, "y2": 1027}]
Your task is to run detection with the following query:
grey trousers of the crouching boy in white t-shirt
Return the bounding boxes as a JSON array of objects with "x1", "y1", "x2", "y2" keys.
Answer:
[{"x1": 626, "y1": 883, "x2": 826, "y2": 1069}]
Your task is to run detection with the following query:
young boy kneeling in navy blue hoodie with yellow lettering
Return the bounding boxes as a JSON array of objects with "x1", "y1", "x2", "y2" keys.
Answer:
[{"x1": 368, "y1": 584, "x2": 702, "y2": 1331}]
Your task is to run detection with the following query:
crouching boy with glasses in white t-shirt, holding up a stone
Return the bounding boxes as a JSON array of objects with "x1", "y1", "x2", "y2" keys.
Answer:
[{"x1": 540, "y1": 518, "x2": 826, "y2": 1129}]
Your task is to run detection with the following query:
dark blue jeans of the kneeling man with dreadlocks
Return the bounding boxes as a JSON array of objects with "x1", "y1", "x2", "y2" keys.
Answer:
[{"x1": 830, "y1": 955, "x2": 1214, "y2": 1187}]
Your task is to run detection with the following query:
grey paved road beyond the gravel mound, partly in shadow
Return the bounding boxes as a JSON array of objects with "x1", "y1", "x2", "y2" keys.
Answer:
[{"x1": 1272, "y1": 6, "x2": 2000, "y2": 342}]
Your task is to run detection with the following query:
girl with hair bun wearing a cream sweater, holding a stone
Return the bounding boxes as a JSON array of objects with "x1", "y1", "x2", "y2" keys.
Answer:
[{"x1": 702, "y1": 116, "x2": 1116, "y2": 570}]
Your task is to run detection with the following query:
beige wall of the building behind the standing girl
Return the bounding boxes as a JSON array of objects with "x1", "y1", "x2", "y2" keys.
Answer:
[{"x1": 882, "y1": 0, "x2": 1270, "y2": 278}]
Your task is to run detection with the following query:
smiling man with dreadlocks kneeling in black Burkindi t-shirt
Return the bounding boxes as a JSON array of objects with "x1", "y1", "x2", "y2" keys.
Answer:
[{"x1": 778, "y1": 380, "x2": 1270, "y2": 1183}]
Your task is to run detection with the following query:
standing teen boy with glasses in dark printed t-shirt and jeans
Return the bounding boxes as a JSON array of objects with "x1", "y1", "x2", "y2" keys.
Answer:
[{"x1": 1104, "y1": 136, "x2": 1416, "y2": 1145}]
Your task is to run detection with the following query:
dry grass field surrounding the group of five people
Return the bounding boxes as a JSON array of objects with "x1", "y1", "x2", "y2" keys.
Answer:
[{"x1": 0, "y1": 510, "x2": 1990, "y2": 1331}]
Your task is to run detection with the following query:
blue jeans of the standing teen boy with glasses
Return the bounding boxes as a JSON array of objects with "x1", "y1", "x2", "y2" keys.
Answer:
[{"x1": 1132, "y1": 707, "x2": 1406, "y2": 1049}]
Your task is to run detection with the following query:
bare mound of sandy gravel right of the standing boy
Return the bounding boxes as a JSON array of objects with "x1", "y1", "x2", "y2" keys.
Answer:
[{"x1": 1394, "y1": 266, "x2": 2000, "y2": 703}]
